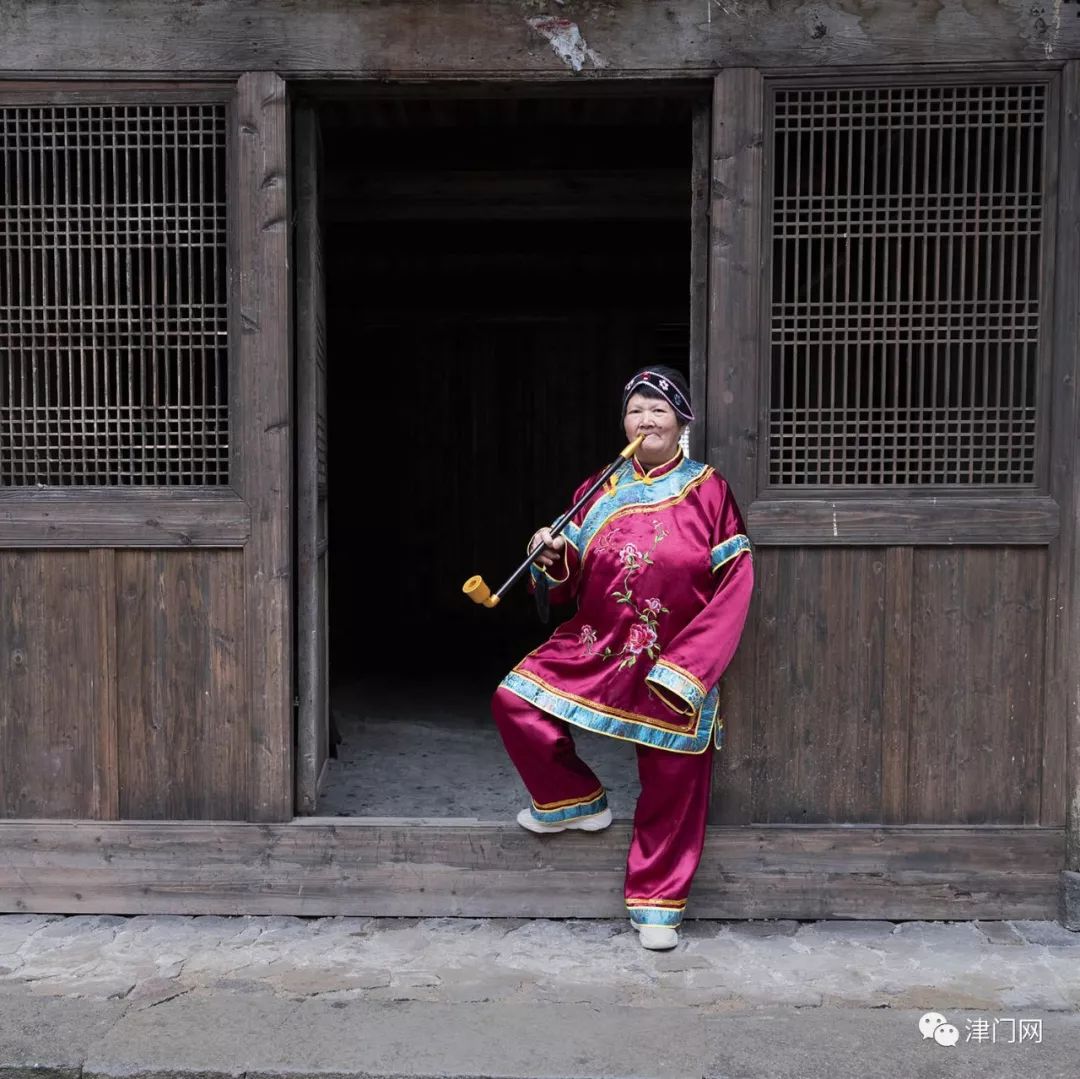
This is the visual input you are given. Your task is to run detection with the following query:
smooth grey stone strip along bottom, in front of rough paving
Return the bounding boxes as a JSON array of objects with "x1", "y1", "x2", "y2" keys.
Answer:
[{"x1": 10, "y1": 993, "x2": 1080, "y2": 1079}]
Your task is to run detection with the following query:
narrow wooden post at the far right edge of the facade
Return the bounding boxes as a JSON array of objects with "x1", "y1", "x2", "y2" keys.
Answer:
[{"x1": 1043, "y1": 60, "x2": 1080, "y2": 930}]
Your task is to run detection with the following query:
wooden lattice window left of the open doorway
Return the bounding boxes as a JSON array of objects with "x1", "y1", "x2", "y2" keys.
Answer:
[{"x1": 0, "y1": 103, "x2": 229, "y2": 486}]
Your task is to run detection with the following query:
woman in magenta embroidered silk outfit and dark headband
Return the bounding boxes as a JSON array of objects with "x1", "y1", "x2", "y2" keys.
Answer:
[{"x1": 492, "y1": 367, "x2": 754, "y2": 948}]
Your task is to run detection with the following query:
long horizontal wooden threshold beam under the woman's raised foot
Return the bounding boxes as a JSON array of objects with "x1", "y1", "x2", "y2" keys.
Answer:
[{"x1": 0, "y1": 818, "x2": 1065, "y2": 919}]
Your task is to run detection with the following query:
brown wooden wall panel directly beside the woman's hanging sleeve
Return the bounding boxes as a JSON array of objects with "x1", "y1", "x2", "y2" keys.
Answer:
[{"x1": 743, "y1": 548, "x2": 885, "y2": 824}]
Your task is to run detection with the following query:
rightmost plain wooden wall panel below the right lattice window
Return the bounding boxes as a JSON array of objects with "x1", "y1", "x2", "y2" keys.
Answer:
[{"x1": 907, "y1": 548, "x2": 1047, "y2": 824}]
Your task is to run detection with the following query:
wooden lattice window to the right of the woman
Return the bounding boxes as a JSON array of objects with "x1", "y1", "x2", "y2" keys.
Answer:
[{"x1": 767, "y1": 83, "x2": 1048, "y2": 487}]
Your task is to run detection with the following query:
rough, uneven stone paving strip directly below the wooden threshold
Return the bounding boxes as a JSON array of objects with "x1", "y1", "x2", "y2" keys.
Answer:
[{"x1": 0, "y1": 915, "x2": 1080, "y2": 1011}]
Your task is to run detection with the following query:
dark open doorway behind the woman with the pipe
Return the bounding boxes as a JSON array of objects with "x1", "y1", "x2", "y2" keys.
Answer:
[{"x1": 319, "y1": 95, "x2": 694, "y2": 818}]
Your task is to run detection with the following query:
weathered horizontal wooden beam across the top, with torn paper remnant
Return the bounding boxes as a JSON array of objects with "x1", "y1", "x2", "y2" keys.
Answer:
[{"x1": 0, "y1": 0, "x2": 1080, "y2": 77}]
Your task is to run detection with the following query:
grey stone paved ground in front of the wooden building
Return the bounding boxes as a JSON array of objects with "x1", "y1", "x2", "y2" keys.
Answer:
[{"x1": 0, "y1": 915, "x2": 1080, "y2": 1079}]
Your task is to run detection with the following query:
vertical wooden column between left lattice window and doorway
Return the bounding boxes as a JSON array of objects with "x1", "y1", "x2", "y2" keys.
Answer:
[{"x1": 232, "y1": 71, "x2": 293, "y2": 821}]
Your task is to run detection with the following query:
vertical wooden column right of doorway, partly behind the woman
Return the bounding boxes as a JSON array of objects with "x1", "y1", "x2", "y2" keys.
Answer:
[{"x1": 705, "y1": 68, "x2": 765, "y2": 824}]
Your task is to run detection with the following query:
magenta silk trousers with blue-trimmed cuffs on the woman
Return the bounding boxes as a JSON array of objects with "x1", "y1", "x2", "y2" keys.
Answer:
[{"x1": 491, "y1": 688, "x2": 713, "y2": 926}]
